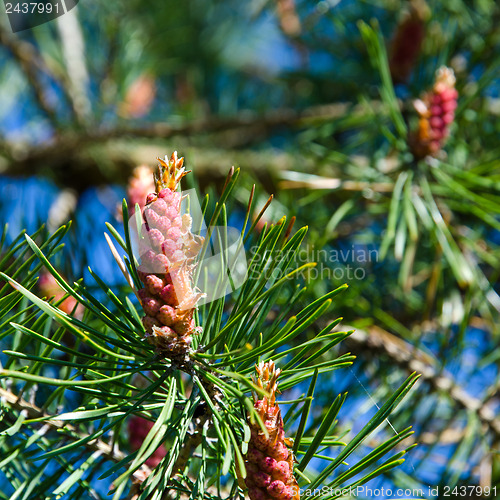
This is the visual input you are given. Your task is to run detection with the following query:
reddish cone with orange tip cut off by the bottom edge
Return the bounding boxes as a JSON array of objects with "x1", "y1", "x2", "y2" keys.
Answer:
[{"x1": 245, "y1": 361, "x2": 300, "y2": 500}]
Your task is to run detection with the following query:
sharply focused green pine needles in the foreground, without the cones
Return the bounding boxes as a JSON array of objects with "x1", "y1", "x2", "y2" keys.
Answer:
[{"x1": 0, "y1": 171, "x2": 418, "y2": 500}]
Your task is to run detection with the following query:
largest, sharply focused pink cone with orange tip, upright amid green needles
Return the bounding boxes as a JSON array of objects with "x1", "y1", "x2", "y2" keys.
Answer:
[{"x1": 139, "y1": 153, "x2": 201, "y2": 356}]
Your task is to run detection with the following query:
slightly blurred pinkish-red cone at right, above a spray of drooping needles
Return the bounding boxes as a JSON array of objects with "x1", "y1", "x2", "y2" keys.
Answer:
[{"x1": 410, "y1": 66, "x2": 458, "y2": 158}]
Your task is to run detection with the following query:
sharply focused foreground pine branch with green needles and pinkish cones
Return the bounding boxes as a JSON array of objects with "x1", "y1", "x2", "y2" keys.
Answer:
[{"x1": 0, "y1": 153, "x2": 418, "y2": 500}]
